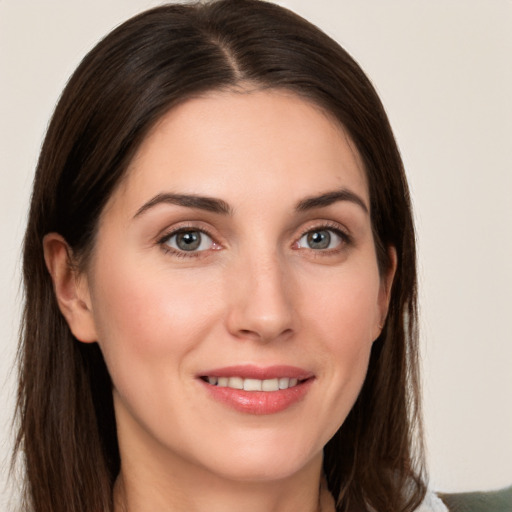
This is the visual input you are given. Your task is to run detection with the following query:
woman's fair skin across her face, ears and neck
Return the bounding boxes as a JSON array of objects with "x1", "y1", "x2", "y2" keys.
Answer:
[{"x1": 45, "y1": 91, "x2": 395, "y2": 512}]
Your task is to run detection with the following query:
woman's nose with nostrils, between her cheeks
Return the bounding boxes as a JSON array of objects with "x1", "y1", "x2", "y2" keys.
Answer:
[{"x1": 227, "y1": 254, "x2": 297, "y2": 343}]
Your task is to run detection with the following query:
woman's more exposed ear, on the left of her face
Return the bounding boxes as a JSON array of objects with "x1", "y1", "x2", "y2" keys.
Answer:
[{"x1": 43, "y1": 233, "x2": 97, "y2": 343}]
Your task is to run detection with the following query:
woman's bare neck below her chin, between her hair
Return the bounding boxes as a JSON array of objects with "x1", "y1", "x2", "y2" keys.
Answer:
[{"x1": 114, "y1": 457, "x2": 322, "y2": 512}]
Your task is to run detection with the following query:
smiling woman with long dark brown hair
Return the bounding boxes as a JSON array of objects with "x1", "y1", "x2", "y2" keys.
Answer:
[{"x1": 17, "y1": 0, "x2": 448, "y2": 512}]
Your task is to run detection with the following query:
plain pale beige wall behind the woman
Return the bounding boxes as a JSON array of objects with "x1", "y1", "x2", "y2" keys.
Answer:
[{"x1": 0, "y1": 0, "x2": 512, "y2": 509}]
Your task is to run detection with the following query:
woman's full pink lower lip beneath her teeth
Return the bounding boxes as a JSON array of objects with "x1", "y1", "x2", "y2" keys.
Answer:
[{"x1": 200, "y1": 378, "x2": 314, "y2": 415}]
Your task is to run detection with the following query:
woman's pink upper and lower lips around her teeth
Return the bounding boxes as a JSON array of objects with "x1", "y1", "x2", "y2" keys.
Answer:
[{"x1": 198, "y1": 365, "x2": 315, "y2": 415}]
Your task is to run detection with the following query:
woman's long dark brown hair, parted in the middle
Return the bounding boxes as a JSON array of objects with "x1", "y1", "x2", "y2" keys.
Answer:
[{"x1": 16, "y1": 0, "x2": 425, "y2": 512}]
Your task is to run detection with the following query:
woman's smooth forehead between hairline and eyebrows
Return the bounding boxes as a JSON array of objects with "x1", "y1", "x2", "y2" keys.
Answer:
[{"x1": 109, "y1": 90, "x2": 368, "y2": 213}]
